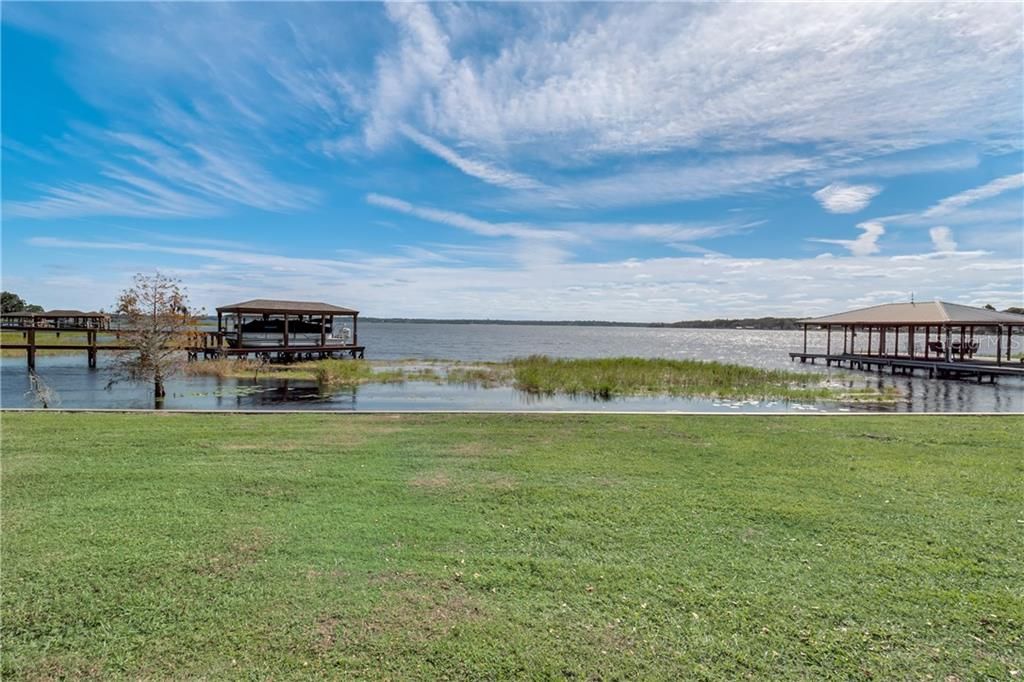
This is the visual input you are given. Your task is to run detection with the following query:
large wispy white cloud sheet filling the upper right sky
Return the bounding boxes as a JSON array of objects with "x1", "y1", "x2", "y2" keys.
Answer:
[{"x1": 372, "y1": 3, "x2": 1022, "y2": 158}]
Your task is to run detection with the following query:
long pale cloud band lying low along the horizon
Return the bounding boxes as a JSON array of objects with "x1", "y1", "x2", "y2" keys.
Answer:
[{"x1": 25, "y1": 232, "x2": 1022, "y2": 322}]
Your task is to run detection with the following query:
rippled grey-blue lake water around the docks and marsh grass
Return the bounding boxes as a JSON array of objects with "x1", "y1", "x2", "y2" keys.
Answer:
[{"x1": 0, "y1": 322, "x2": 1024, "y2": 413}]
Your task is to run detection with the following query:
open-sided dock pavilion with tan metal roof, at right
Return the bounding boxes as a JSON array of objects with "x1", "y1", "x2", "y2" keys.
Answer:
[{"x1": 790, "y1": 301, "x2": 1024, "y2": 378}]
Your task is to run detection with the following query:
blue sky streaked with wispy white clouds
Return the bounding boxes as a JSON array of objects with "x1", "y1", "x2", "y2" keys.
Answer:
[{"x1": 0, "y1": 2, "x2": 1024, "y2": 322}]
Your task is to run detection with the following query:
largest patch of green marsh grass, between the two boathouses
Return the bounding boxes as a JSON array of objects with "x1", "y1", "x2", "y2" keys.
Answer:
[{"x1": 510, "y1": 355, "x2": 839, "y2": 398}]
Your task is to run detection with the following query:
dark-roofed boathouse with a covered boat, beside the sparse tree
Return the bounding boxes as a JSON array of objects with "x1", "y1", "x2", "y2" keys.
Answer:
[{"x1": 204, "y1": 299, "x2": 364, "y2": 357}]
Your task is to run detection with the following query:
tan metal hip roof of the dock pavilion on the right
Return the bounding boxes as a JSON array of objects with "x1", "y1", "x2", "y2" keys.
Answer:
[{"x1": 800, "y1": 301, "x2": 1024, "y2": 327}]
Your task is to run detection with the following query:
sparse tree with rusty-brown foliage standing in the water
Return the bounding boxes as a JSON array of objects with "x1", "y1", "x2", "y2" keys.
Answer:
[{"x1": 109, "y1": 272, "x2": 198, "y2": 404}]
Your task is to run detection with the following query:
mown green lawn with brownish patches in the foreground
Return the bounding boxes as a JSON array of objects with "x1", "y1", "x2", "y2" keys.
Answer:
[{"x1": 0, "y1": 413, "x2": 1024, "y2": 680}]
